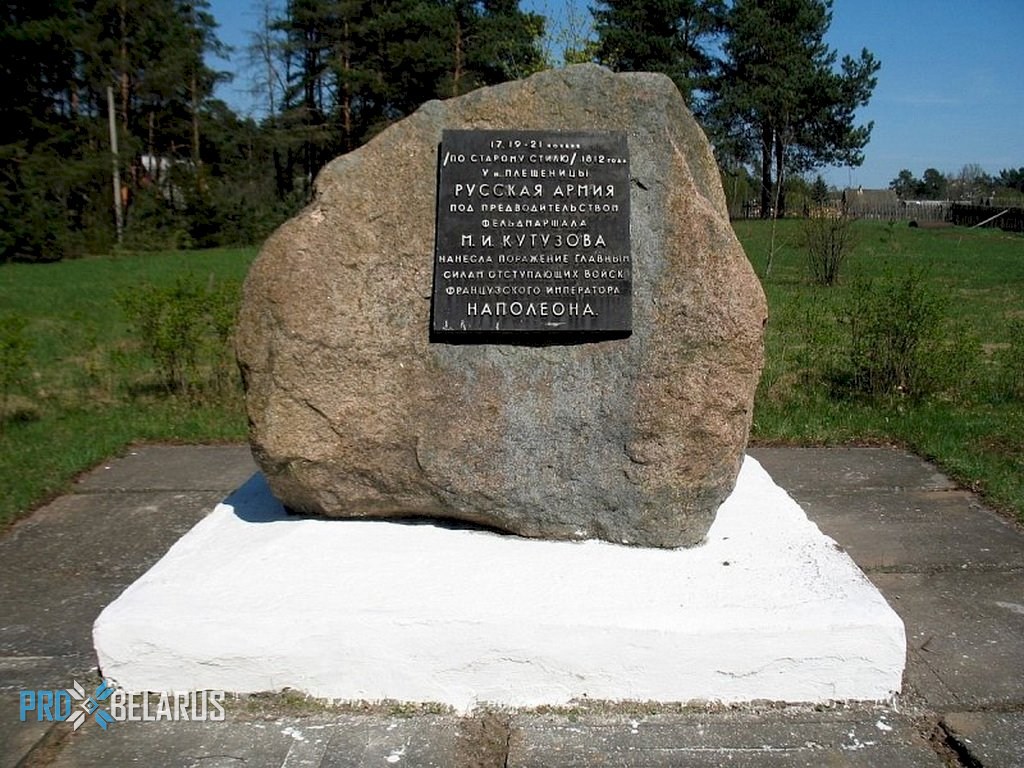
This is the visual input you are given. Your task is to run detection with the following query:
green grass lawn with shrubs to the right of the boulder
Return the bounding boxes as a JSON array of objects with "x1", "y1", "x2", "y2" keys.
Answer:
[{"x1": 734, "y1": 221, "x2": 1024, "y2": 522}]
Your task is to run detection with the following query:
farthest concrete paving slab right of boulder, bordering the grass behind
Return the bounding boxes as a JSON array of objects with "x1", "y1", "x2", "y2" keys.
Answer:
[{"x1": 749, "y1": 446, "x2": 956, "y2": 502}]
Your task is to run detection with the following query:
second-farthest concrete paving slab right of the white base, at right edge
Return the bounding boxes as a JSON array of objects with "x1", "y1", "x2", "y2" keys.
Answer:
[{"x1": 774, "y1": 490, "x2": 1024, "y2": 571}]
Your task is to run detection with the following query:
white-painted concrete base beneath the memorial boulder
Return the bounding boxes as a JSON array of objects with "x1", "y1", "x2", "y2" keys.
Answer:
[{"x1": 93, "y1": 457, "x2": 906, "y2": 711}]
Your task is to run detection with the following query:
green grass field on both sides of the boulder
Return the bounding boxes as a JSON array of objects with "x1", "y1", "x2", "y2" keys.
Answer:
[{"x1": 0, "y1": 221, "x2": 1024, "y2": 526}]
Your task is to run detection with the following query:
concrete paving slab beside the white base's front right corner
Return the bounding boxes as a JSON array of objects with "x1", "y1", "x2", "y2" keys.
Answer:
[{"x1": 871, "y1": 569, "x2": 1024, "y2": 712}]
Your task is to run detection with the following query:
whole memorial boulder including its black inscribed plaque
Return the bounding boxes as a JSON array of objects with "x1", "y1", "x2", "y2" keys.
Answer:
[{"x1": 237, "y1": 65, "x2": 767, "y2": 547}]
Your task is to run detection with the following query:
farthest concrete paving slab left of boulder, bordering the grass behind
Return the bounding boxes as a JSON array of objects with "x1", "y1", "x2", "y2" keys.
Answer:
[{"x1": 75, "y1": 444, "x2": 257, "y2": 495}]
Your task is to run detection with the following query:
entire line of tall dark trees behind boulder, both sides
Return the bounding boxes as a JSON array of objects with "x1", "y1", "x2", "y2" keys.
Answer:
[{"x1": 0, "y1": 0, "x2": 929, "y2": 259}]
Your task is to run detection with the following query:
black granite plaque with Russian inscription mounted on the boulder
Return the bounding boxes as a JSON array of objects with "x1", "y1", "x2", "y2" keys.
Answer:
[{"x1": 431, "y1": 130, "x2": 633, "y2": 336}]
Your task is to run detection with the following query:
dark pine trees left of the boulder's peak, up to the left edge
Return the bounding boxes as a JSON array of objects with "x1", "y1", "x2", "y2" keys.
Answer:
[{"x1": 0, "y1": 0, "x2": 543, "y2": 260}]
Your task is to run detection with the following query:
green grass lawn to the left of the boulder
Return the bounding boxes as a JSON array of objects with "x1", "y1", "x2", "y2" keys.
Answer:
[{"x1": 0, "y1": 249, "x2": 255, "y2": 527}]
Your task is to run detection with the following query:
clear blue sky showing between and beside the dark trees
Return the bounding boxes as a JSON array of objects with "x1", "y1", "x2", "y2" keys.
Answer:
[{"x1": 210, "y1": 0, "x2": 1024, "y2": 188}]
